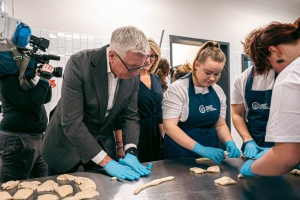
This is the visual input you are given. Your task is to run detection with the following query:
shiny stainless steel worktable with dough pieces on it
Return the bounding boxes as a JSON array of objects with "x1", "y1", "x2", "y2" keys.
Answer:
[{"x1": 1, "y1": 158, "x2": 300, "y2": 200}]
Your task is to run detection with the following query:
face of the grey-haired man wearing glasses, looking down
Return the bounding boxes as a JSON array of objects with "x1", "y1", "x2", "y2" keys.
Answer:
[{"x1": 108, "y1": 50, "x2": 147, "y2": 79}]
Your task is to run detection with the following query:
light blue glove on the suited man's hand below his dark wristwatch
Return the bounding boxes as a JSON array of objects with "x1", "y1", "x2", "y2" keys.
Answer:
[{"x1": 119, "y1": 153, "x2": 152, "y2": 176}]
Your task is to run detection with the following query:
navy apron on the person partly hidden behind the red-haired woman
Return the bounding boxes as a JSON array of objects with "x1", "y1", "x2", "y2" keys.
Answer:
[{"x1": 242, "y1": 67, "x2": 277, "y2": 151}]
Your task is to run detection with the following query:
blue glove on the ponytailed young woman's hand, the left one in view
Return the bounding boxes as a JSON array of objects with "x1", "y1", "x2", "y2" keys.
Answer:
[{"x1": 193, "y1": 143, "x2": 225, "y2": 164}]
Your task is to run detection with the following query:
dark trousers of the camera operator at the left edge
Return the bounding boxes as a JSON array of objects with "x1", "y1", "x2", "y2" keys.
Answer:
[{"x1": 0, "y1": 131, "x2": 48, "y2": 183}]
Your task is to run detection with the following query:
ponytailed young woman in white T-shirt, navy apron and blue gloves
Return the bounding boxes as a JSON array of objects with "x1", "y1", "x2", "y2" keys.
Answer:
[{"x1": 163, "y1": 41, "x2": 240, "y2": 163}]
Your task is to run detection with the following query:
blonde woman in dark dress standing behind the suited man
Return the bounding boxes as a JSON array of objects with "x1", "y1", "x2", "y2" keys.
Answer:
[{"x1": 138, "y1": 38, "x2": 164, "y2": 162}]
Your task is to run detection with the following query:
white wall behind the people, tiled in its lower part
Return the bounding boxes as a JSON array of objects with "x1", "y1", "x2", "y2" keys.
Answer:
[{"x1": 0, "y1": 0, "x2": 300, "y2": 146}]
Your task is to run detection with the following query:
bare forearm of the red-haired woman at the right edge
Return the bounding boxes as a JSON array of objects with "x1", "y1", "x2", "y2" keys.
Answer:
[{"x1": 251, "y1": 143, "x2": 300, "y2": 176}]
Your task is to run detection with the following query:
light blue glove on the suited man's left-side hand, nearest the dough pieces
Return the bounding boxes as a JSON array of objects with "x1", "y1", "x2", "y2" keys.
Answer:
[{"x1": 103, "y1": 160, "x2": 140, "y2": 181}]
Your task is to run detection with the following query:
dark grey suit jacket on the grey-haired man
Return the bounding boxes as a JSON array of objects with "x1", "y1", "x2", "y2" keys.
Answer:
[{"x1": 41, "y1": 46, "x2": 140, "y2": 172}]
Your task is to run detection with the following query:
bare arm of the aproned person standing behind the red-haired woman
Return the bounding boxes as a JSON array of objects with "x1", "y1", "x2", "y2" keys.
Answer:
[{"x1": 231, "y1": 104, "x2": 253, "y2": 143}]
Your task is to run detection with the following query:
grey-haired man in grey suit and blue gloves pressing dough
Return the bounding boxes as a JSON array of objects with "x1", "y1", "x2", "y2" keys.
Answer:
[{"x1": 41, "y1": 26, "x2": 151, "y2": 180}]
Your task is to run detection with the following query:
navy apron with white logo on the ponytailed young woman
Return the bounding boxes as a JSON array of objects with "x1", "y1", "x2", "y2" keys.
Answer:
[{"x1": 163, "y1": 74, "x2": 221, "y2": 159}]
